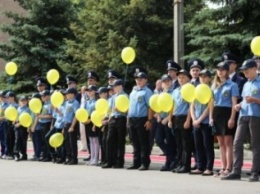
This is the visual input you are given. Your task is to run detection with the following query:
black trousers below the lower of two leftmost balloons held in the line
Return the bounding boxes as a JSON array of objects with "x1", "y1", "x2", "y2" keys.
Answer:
[{"x1": 14, "y1": 126, "x2": 28, "y2": 159}]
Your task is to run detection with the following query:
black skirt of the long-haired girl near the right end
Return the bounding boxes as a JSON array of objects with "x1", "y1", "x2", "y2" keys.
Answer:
[{"x1": 213, "y1": 107, "x2": 235, "y2": 136}]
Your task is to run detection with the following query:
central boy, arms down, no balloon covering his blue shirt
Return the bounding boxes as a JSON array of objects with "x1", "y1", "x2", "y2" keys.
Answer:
[{"x1": 128, "y1": 72, "x2": 153, "y2": 170}]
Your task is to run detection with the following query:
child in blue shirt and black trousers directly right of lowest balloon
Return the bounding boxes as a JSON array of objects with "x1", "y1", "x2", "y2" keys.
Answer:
[{"x1": 63, "y1": 88, "x2": 79, "y2": 165}]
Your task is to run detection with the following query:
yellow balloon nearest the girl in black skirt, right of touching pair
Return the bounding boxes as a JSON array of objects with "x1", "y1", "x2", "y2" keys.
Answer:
[{"x1": 195, "y1": 84, "x2": 212, "y2": 104}]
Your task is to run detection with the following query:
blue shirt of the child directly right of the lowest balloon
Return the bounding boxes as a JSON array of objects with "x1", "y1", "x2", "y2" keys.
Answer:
[{"x1": 63, "y1": 98, "x2": 79, "y2": 123}]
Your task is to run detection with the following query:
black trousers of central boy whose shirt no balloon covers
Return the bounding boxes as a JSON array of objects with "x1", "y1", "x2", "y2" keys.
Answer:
[{"x1": 129, "y1": 117, "x2": 151, "y2": 167}]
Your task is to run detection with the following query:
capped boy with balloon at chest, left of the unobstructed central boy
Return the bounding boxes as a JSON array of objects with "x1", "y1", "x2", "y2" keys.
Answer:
[{"x1": 103, "y1": 79, "x2": 127, "y2": 168}]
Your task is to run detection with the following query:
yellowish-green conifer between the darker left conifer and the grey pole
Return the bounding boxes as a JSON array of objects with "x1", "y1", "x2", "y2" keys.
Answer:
[{"x1": 63, "y1": 0, "x2": 203, "y2": 85}]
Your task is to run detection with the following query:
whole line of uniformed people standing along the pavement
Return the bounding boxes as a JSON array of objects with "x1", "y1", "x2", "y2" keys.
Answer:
[{"x1": 0, "y1": 53, "x2": 260, "y2": 181}]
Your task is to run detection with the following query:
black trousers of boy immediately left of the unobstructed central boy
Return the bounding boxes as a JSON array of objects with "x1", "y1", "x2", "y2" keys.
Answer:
[{"x1": 107, "y1": 116, "x2": 126, "y2": 166}]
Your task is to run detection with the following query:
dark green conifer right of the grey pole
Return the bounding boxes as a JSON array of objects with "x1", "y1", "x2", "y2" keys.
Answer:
[{"x1": 185, "y1": 0, "x2": 260, "y2": 65}]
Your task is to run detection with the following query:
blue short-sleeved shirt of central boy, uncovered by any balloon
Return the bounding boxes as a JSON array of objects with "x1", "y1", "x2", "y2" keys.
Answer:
[{"x1": 128, "y1": 86, "x2": 153, "y2": 118}]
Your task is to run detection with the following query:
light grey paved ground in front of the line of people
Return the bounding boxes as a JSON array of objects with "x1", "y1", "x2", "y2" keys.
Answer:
[{"x1": 0, "y1": 142, "x2": 260, "y2": 194}]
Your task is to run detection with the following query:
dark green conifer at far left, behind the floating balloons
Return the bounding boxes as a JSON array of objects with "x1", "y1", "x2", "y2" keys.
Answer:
[{"x1": 0, "y1": 0, "x2": 75, "y2": 91}]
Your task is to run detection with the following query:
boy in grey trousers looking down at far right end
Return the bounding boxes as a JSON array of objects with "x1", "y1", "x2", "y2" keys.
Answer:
[{"x1": 221, "y1": 59, "x2": 260, "y2": 182}]
